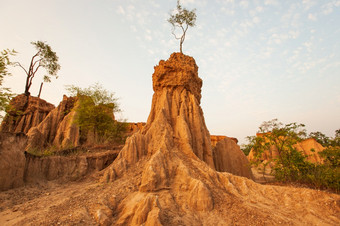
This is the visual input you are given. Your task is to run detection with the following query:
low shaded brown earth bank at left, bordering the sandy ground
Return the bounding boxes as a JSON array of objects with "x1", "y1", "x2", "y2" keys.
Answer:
[{"x1": 0, "y1": 132, "x2": 119, "y2": 191}]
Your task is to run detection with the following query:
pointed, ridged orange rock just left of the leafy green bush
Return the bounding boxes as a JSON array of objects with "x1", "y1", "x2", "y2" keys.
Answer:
[{"x1": 27, "y1": 95, "x2": 79, "y2": 150}]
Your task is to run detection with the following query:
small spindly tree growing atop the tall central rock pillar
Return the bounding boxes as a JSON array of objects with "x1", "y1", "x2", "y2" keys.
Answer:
[{"x1": 168, "y1": 0, "x2": 197, "y2": 53}]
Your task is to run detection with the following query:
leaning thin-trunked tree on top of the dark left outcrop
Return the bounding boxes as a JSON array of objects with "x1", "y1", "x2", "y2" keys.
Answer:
[{"x1": 13, "y1": 41, "x2": 60, "y2": 95}]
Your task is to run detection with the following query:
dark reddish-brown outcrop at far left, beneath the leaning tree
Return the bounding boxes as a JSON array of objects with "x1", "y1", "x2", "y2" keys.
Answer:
[{"x1": 1, "y1": 94, "x2": 55, "y2": 133}]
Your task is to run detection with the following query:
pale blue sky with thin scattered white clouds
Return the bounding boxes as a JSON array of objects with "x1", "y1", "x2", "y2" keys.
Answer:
[{"x1": 0, "y1": 0, "x2": 340, "y2": 143}]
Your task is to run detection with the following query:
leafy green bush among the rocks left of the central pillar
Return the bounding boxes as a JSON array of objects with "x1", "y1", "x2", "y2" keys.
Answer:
[{"x1": 67, "y1": 83, "x2": 127, "y2": 143}]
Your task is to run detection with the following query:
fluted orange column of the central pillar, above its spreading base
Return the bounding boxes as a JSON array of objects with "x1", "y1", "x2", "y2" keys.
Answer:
[{"x1": 102, "y1": 53, "x2": 215, "y2": 184}]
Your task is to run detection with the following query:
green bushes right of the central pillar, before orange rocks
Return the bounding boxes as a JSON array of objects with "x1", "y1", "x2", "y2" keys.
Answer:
[{"x1": 247, "y1": 119, "x2": 340, "y2": 192}]
